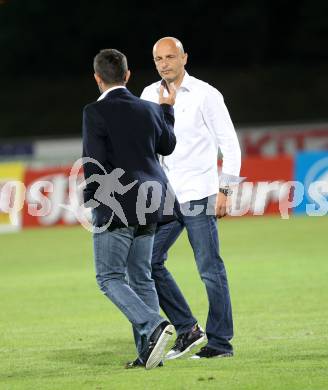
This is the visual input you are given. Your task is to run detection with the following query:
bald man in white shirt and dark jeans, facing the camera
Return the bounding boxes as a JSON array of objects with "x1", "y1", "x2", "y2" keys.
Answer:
[{"x1": 141, "y1": 37, "x2": 241, "y2": 359}]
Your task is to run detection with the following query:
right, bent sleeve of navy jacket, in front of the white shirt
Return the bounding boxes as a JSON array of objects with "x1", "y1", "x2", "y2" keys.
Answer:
[{"x1": 156, "y1": 104, "x2": 176, "y2": 156}]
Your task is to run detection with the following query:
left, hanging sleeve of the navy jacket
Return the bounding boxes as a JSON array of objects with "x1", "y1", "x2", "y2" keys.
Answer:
[{"x1": 82, "y1": 105, "x2": 106, "y2": 202}]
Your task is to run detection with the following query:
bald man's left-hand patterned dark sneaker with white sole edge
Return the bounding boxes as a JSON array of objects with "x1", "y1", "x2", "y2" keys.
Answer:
[{"x1": 165, "y1": 324, "x2": 206, "y2": 360}]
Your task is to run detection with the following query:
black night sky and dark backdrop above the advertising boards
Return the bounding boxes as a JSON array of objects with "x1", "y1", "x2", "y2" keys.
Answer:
[{"x1": 0, "y1": 0, "x2": 328, "y2": 139}]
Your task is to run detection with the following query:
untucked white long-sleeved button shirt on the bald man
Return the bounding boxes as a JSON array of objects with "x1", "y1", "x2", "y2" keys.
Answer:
[{"x1": 141, "y1": 72, "x2": 241, "y2": 203}]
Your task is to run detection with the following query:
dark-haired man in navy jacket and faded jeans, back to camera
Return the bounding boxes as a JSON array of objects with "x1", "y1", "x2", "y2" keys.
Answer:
[{"x1": 83, "y1": 49, "x2": 176, "y2": 369}]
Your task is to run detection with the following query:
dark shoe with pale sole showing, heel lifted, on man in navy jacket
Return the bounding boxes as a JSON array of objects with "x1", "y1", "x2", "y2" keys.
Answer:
[{"x1": 141, "y1": 321, "x2": 174, "y2": 370}]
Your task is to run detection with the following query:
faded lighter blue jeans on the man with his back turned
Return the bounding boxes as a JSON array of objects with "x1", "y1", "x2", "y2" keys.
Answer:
[{"x1": 93, "y1": 226, "x2": 164, "y2": 354}]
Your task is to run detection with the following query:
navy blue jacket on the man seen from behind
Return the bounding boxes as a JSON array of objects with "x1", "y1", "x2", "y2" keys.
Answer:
[{"x1": 83, "y1": 88, "x2": 176, "y2": 227}]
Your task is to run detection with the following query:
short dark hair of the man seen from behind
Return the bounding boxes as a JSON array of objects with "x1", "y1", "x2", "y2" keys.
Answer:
[{"x1": 93, "y1": 49, "x2": 128, "y2": 85}]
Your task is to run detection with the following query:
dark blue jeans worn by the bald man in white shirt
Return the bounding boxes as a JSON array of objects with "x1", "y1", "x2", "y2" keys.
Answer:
[{"x1": 152, "y1": 198, "x2": 233, "y2": 352}]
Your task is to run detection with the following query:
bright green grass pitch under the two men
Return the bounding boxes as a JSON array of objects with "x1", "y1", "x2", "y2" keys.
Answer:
[{"x1": 0, "y1": 217, "x2": 328, "y2": 390}]
